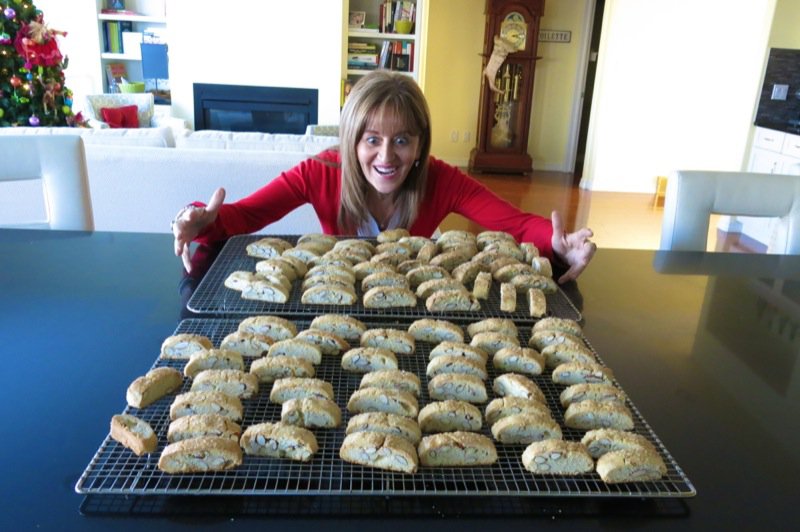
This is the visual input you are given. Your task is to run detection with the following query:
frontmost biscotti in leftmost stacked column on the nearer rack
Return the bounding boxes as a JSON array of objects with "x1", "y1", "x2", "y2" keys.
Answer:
[{"x1": 158, "y1": 436, "x2": 242, "y2": 474}]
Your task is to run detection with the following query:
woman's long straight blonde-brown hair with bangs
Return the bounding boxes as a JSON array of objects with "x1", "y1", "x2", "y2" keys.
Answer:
[{"x1": 337, "y1": 70, "x2": 431, "y2": 234}]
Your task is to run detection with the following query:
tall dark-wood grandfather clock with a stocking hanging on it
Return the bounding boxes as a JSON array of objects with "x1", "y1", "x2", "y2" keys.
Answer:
[{"x1": 469, "y1": 0, "x2": 544, "y2": 173}]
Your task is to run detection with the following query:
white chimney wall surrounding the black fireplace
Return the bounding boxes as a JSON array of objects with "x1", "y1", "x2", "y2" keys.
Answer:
[{"x1": 167, "y1": 0, "x2": 343, "y2": 124}]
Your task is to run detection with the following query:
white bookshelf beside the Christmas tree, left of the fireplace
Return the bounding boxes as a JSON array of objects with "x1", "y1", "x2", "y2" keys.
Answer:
[{"x1": 96, "y1": 0, "x2": 167, "y2": 92}]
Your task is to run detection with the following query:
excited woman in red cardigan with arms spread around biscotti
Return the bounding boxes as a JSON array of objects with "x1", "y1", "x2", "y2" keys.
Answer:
[{"x1": 172, "y1": 70, "x2": 596, "y2": 283}]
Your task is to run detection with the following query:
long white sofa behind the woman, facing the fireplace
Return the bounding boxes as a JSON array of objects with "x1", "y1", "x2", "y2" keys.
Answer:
[{"x1": 0, "y1": 128, "x2": 338, "y2": 234}]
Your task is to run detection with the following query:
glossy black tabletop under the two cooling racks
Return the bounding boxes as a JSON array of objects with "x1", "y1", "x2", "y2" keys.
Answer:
[{"x1": 0, "y1": 230, "x2": 800, "y2": 530}]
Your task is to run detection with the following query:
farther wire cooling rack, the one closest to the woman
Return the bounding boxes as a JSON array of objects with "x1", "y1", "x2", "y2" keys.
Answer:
[{"x1": 186, "y1": 235, "x2": 581, "y2": 321}]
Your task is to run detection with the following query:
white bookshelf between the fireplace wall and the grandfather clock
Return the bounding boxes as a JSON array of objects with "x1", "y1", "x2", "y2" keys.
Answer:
[{"x1": 342, "y1": 0, "x2": 425, "y2": 84}]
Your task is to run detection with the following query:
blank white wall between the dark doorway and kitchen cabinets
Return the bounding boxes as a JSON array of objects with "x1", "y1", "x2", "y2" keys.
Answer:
[{"x1": 581, "y1": 0, "x2": 775, "y2": 192}]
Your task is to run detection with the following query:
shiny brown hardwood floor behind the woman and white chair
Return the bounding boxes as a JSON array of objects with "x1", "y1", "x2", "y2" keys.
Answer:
[{"x1": 441, "y1": 170, "x2": 764, "y2": 253}]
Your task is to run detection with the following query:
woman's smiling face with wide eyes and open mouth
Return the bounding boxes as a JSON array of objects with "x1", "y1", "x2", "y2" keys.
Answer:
[{"x1": 356, "y1": 112, "x2": 420, "y2": 195}]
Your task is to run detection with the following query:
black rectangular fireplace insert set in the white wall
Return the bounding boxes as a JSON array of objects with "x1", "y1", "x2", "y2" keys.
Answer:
[{"x1": 194, "y1": 83, "x2": 318, "y2": 135}]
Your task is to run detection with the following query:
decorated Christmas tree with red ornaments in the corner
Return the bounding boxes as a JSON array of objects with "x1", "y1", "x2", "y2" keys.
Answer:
[{"x1": 0, "y1": 0, "x2": 83, "y2": 127}]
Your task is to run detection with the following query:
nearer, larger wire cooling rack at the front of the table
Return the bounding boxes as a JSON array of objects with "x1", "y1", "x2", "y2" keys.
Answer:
[{"x1": 75, "y1": 318, "x2": 696, "y2": 498}]
